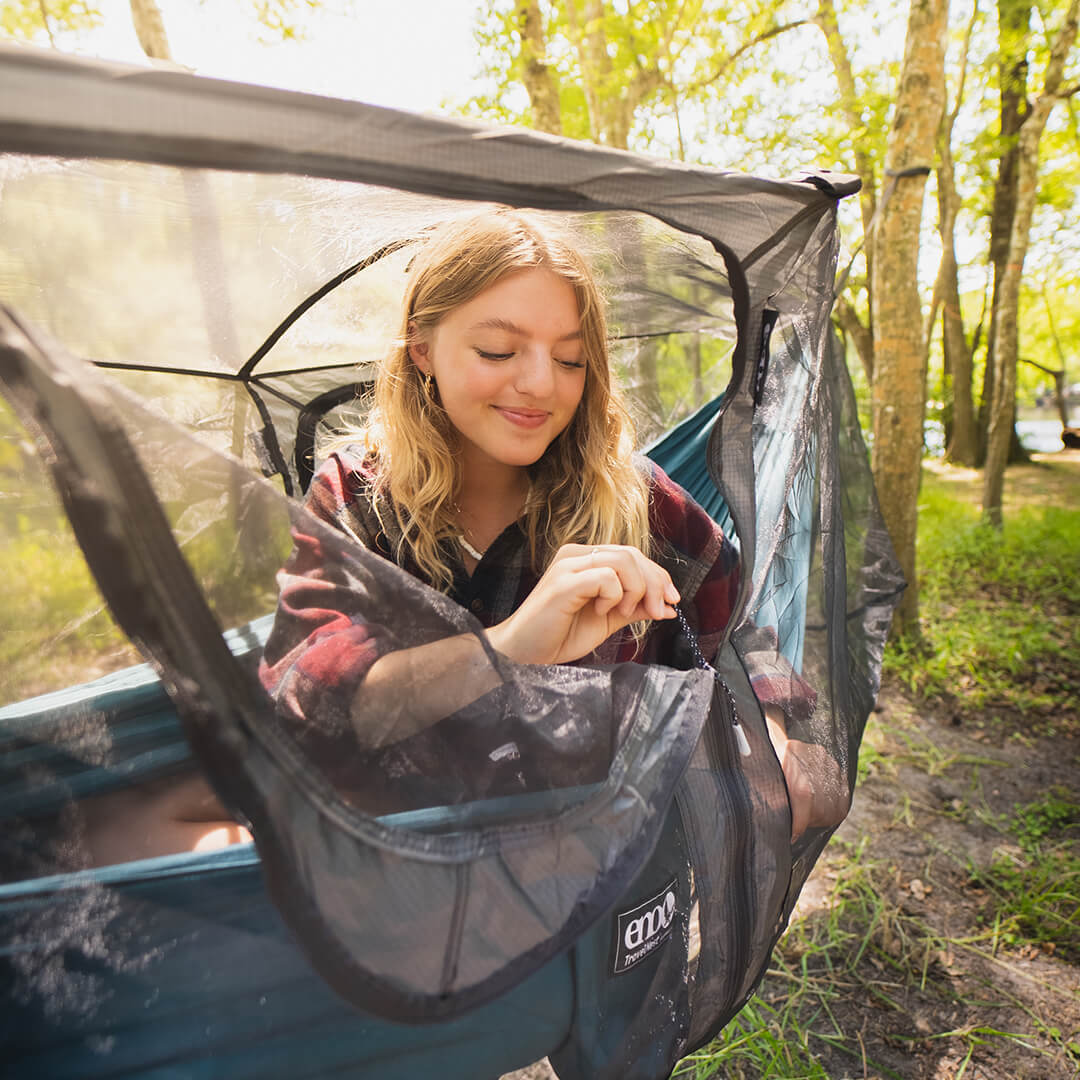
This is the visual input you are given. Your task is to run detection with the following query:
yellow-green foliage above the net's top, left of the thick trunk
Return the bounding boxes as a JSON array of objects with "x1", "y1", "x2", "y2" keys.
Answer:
[{"x1": 460, "y1": 0, "x2": 813, "y2": 159}]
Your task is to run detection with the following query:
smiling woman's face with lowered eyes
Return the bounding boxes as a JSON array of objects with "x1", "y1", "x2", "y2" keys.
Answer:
[{"x1": 409, "y1": 268, "x2": 585, "y2": 468}]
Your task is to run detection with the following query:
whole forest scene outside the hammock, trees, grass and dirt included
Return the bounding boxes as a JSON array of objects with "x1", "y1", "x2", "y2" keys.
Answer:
[{"x1": 6, "y1": 0, "x2": 1080, "y2": 1077}]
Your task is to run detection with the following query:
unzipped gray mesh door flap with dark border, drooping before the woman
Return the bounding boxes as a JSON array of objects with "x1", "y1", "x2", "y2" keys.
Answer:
[{"x1": 0, "y1": 319, "x2": 712, "y2": 1022}]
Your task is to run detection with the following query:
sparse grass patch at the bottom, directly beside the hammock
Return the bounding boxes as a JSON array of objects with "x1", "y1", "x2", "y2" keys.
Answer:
[{"x1": 674, "y1": 836, "x2": 1062, "y2": 1080}]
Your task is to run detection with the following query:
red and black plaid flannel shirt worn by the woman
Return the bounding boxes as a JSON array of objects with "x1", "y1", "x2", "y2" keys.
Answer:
[{"x1": 260, "y1": 451, "x2": 814, "y2": 725}]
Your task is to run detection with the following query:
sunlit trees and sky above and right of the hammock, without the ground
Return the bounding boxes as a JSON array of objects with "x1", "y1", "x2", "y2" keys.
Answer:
[{"x1": 0, "y1": 0, "x2": 1080, "y2": 635}]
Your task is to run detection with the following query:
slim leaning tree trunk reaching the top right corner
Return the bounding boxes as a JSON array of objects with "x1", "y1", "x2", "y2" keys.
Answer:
[{"x1": 983, "y1": 0, "x2": 1080, "y2": 527}]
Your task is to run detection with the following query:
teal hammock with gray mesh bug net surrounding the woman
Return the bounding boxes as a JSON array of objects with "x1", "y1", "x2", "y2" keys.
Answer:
[{"x1": 0, "y1": 42, "x2": 902, "y2": 1077}]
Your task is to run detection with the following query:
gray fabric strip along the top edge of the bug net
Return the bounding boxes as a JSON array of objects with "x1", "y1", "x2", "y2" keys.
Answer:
[{"x1": 0, "y1": 46, "x2": 854, "y2": 270}]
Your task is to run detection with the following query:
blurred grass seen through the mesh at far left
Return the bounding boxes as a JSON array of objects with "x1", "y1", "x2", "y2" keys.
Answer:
[{"x1": 0, "y1": 401, "x2": 291, "y2": 705}]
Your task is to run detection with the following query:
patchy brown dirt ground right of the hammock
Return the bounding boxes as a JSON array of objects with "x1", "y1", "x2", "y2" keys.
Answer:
[{"x1": 761, "y1": 685, "x2": 1080, "y2": 1080}]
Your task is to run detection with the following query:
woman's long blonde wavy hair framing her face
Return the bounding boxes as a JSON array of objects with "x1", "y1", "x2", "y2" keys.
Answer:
[{"x1": 361, "y1": 211, "x2": 649, "y2": 590}]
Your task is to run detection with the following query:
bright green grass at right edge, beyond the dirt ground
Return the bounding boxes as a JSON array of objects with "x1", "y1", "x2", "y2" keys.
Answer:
[{"x1": 885, "y1": 462, "x2": 1080, "y2": 727}]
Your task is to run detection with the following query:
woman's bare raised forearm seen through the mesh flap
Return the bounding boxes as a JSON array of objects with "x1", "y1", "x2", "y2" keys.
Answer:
[{"x1": 350, "y1": 634, "x2": 502, "y2": 750}]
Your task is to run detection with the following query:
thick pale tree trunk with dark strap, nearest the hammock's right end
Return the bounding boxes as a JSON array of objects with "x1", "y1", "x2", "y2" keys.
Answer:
[{"x1": 870, "y1": 0, "x2": 948, "y2": 632}]
